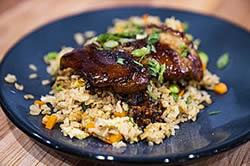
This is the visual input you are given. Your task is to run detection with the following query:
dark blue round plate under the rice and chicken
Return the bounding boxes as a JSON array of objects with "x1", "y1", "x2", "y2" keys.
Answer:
[{"x1": 0, "y1": 7, "x2": 250, "y2": 163}]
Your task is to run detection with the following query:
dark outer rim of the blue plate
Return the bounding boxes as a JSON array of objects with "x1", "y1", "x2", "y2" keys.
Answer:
[{"x1": 0, "y1": 5, "x2": 250, "y2": 164}]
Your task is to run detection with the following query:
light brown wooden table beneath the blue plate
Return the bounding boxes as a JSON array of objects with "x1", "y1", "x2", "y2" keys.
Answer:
[{"x1": 0, "y1": 0, "x2": 250, "y2": 166}]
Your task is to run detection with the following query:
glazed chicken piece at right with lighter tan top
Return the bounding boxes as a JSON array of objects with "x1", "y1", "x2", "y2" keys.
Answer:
[{"x1": 118, "y1": 25, "x2": 203, "y2": 81}]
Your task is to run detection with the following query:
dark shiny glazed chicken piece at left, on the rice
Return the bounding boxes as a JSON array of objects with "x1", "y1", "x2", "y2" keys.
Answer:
[{"x1": 60, "y1": 44, "x2": 150, "y2": 94}]
